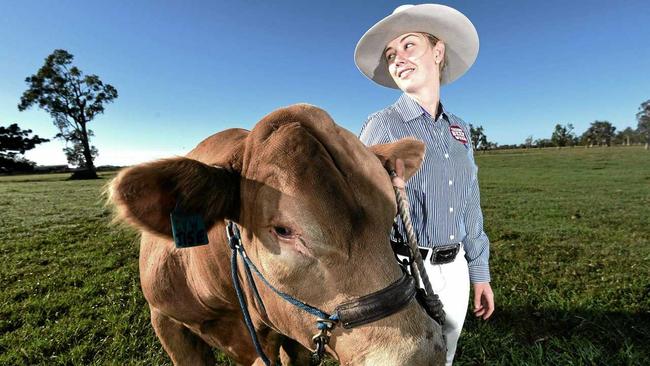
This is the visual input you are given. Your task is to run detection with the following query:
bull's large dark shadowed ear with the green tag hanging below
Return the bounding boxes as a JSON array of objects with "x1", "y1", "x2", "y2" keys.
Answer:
[{"x1": 110, "y1": 158, "x2": 239, "y2": 237}]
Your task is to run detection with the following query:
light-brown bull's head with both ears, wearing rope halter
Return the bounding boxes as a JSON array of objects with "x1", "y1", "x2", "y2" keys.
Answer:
[{"x1": 112, "y1": 105, "x2": 444, "y2": 365}]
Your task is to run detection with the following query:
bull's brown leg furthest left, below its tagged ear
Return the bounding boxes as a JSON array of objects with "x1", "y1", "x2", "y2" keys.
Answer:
[{"x1": 151, "y1": 307, "x2": 215, "y2": 365}]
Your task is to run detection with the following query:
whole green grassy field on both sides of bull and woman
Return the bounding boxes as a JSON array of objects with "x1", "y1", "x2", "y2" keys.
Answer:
[{"x1": 0, "y1": 147, "x2": 650, "y2": 365}]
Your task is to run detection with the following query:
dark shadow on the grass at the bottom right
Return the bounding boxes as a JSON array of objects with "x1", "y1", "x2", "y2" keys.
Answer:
[{"x1": 461, "y1": 307, "x2": 650, "y2": 364}]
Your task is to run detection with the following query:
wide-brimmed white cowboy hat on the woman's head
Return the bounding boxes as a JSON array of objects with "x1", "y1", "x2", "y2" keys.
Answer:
[{"x1": 354, "y1": 4, "x2": 478, "y2": 89}]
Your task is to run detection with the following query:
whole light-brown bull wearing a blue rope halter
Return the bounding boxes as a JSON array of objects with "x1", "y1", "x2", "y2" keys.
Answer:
[{"x1": 111, "y1": 105, "x2": 445, "y2": 365}]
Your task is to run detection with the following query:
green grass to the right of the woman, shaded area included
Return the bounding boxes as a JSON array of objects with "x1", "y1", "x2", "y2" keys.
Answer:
[{"x1": 458, "y1": 148, "x2": 650, "y2": 365}]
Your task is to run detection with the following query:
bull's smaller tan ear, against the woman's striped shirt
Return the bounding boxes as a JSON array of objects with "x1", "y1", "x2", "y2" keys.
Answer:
[{"x1": 368, "y1": 137, "x2": 425, "y2": 181}]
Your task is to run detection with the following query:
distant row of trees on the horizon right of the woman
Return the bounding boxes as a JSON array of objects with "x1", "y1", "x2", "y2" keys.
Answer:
[{"x1": 470, "y1": 100, "x2": 650, "y2": 150}]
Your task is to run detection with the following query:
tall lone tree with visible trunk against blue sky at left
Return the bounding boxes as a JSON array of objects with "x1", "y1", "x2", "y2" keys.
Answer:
[{"x1": 18, "y1": 50, "x2": 117, "y2": 178}]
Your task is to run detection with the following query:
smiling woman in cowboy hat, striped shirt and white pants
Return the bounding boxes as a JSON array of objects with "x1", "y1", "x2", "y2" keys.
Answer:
[{"x1": 355, "y1": 4, "x2": 494, "y2": 365}]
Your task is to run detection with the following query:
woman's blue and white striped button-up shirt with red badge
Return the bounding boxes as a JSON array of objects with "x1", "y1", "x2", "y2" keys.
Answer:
[{"x1": 359, "y1": 94, "x2": 490, "y2": 283}]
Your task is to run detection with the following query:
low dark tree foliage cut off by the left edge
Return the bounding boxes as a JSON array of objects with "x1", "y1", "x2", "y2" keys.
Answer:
[{"x1": 0, "y1": 123, "x2": 50, "y2": 172}]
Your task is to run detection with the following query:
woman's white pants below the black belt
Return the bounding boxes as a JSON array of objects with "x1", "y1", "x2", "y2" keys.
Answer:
[{"x1": 423, "y1": 244, "x2": 469, "y2": 366}]
